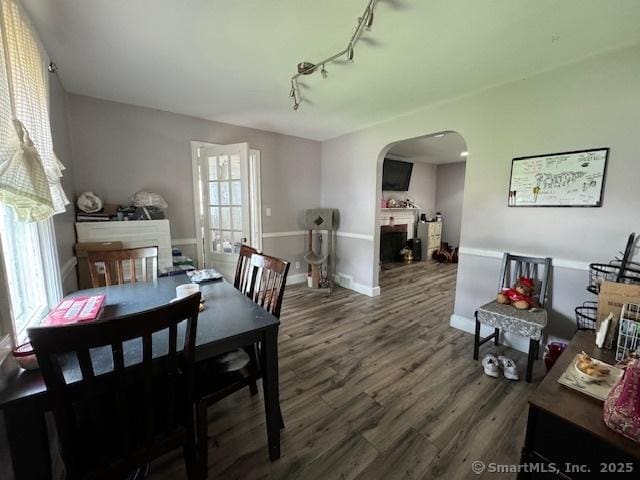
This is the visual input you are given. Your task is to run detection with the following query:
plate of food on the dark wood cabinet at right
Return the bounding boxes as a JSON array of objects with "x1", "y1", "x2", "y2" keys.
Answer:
[{"x1": 558, "y1": 352, "x2": 623, "y2": 401}]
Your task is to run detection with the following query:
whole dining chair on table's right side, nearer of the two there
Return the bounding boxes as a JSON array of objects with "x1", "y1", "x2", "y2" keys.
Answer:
[{"x1": 196, "y1": 253, "x2": 290, "y2": 478}]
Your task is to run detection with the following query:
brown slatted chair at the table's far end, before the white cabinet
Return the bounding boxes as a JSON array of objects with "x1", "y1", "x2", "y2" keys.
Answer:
[{"x1": 87, "y1": 247, "x2": 158, "y2": 288}]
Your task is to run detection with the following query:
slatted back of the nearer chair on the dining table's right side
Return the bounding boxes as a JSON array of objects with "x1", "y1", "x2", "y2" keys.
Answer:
[{"x1": 249, "y1": 253, "x2": 289, "y2": 318}]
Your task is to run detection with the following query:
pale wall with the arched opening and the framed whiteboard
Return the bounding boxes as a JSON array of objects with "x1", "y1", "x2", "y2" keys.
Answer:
[{"x1": 322, "y1": 46, "x2": 640, "y2": 344}]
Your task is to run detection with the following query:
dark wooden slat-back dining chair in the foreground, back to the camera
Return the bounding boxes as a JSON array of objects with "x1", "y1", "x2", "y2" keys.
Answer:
[{"x1": 29, "y1": 293, "x2": 200, "y2": 480}]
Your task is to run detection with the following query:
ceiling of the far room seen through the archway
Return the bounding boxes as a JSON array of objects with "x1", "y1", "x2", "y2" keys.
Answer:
[{"x1": 387, "y1": 132, "x2": 467, "y2": 165}]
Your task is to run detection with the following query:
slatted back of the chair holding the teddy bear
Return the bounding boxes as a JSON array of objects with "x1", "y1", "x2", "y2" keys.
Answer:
[{"x1": 498, "y1": 252, "x2": 551, "y2": 307}]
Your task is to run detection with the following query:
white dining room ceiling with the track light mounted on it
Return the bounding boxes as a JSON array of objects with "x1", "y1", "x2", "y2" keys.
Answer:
[{"x1": 22, "y1": 0, "x2": 640, "y2": 140}]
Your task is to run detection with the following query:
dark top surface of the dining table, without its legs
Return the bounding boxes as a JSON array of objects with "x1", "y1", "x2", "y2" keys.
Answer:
[{"x1": 0, "y1": 275, "x2": 280, "y2": 409}]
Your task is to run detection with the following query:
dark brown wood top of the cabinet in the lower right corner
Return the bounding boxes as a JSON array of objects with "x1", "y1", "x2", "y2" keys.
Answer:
[{"x1": 529, "y1": 331, "x2": 640, "y2": 459}]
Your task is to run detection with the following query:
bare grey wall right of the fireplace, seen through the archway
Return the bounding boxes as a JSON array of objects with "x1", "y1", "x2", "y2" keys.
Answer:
[{"x1": 435, "y1": 162, "x2": 466, "y2": 247}]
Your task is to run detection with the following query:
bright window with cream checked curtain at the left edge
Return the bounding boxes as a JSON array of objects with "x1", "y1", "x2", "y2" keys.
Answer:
[{"x1": 0, "y1": 0, "x2": 68, "y2": 350}]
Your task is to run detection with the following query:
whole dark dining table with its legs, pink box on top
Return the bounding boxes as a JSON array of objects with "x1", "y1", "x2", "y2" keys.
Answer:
[{"x1": 0, "y1": 274, "x2": 280, "y2": 480}]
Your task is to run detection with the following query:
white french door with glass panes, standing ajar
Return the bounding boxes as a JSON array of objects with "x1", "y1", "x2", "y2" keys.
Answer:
[{"x1": 192, "y1": 142, "x2": 260, "y2": 280}]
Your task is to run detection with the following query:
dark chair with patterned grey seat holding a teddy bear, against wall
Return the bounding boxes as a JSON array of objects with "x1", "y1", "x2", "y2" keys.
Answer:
[{"x1": 473, "y1": 252, "x2": 551, "y2": 382}]
